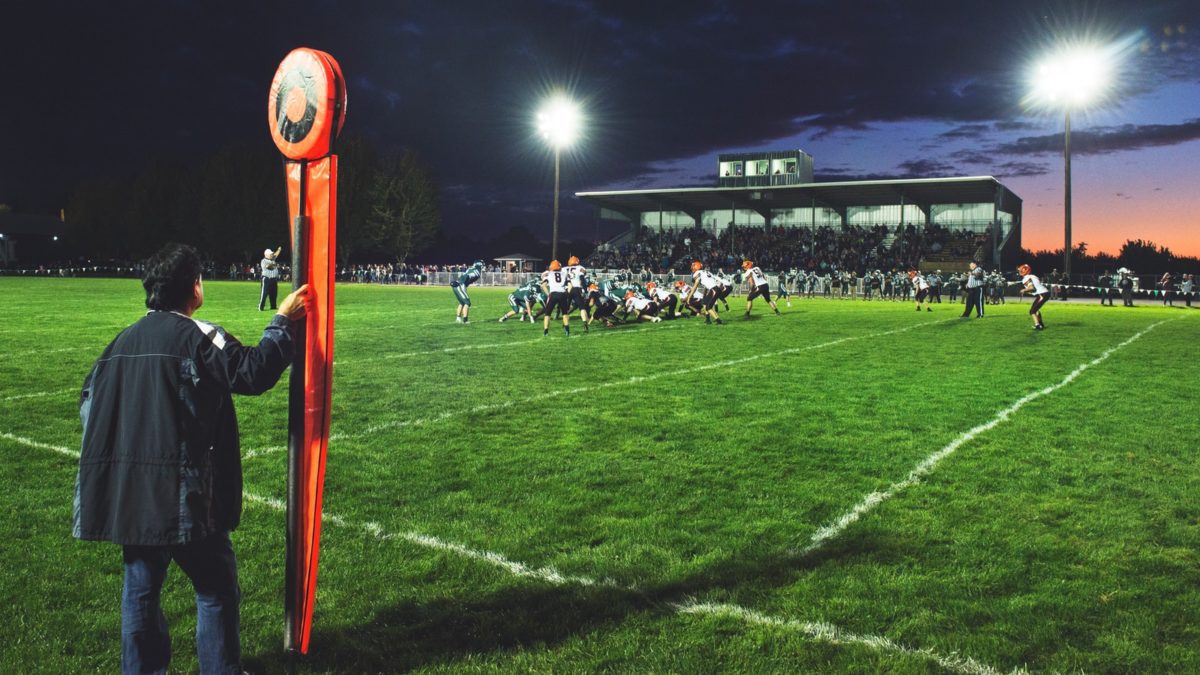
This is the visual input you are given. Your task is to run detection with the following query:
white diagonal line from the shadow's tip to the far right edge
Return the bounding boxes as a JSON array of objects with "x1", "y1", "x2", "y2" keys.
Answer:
[{"x1": 793, "y1": 317, "x2": 1182, "y2": 557}]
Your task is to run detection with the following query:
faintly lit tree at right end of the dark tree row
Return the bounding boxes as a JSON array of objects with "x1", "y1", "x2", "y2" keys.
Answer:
[{"x1": 367, "y1": 149, "x2": 442, "y2": 263}]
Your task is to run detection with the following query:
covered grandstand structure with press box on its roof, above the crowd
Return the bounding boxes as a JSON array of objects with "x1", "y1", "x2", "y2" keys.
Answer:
[{"x1": 575, "y1": 150, "x2": 1021, "y2": 270}]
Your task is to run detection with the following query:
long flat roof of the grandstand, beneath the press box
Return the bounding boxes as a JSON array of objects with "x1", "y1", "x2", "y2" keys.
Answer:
[{"x1": 575, "y1": 175, "x2": 1021, "y2": 213}]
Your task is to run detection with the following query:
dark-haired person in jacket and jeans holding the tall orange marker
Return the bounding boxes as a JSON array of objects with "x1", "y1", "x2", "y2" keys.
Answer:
[{"x1": 73, "y1": 244, "x2": 308, "y2": 673}]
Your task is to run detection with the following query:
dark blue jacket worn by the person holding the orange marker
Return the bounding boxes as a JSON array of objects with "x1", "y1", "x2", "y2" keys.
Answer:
[{"x1": 74, "y1": 311, "x2": 293, "y2": 545}]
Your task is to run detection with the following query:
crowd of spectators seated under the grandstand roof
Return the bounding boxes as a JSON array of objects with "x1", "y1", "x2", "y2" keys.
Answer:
[{"x1": 584, "y1": 225, "x2": 991, "y2": 275}]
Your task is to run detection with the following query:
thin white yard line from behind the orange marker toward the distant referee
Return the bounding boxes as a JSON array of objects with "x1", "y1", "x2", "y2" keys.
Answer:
[{"x1": 242, "y1": 318, "x2": 954, "y2": 459}]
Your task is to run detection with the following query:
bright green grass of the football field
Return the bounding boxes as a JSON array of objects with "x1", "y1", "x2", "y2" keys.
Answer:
[{"x1": 0, "y1": 277, "x2": 1200, "y2": 673}]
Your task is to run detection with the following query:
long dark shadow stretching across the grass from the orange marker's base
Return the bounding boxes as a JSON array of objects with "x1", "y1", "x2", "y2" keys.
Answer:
[{"x1": 247, "y1": 536, "x2": 907, "y2": 673}]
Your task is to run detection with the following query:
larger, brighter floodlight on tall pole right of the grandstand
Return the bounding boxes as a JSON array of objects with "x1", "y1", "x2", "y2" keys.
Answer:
[{"x1": 1030, "y1": 46, "x2": 1117, "y2": 285}]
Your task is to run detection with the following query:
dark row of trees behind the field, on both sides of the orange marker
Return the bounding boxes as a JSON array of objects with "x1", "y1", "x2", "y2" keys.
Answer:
[{"x1": 66, "y1": 136, "x2": 442, "y2": 264}]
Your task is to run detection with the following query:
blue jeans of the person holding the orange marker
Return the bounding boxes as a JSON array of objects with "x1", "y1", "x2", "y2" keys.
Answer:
[{"x1": 121, "y1": 532, "x2": 241, "y2": 674}]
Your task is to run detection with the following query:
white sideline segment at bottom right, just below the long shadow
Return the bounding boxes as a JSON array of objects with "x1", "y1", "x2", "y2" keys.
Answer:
[{"x1": 676, "y1": 602, "x2": 1012, "y2": 675}]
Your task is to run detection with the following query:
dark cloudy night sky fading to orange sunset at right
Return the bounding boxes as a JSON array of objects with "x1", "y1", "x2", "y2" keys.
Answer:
[{"x1": 0, "y1": 0, "x2": 1200, "y2": 256}]
